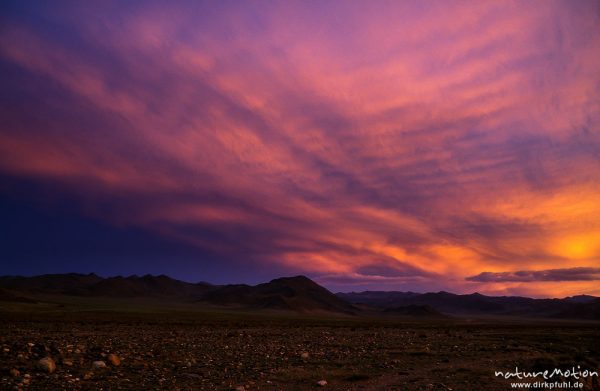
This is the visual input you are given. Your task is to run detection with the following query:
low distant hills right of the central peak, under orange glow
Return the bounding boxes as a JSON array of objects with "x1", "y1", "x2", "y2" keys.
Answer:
[{"x1": 337, "y1": 291, "x2": 600, "y2": 320}]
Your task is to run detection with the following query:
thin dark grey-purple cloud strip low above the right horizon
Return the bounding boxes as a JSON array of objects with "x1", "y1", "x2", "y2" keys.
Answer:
[{"x1": 466, "y1": 267, "x2": 600, "y2": 282}]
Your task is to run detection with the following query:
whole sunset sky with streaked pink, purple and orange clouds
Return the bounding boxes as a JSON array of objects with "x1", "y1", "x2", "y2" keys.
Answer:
[{"x1": 0, "y1": 0, "x2": 600, "y2": 297}]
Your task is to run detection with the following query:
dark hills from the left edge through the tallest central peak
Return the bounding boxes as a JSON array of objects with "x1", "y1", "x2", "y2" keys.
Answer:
[{"x1": 0, "y1": 273, "x2": 356, "y2": 313}]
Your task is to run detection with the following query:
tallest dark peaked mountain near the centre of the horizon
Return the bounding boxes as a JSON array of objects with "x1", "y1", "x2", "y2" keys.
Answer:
[{"x1": 202, "y1": 276, "x2": 356, "y2": 313}]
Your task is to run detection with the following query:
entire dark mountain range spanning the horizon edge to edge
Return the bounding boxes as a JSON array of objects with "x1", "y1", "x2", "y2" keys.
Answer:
[{"x1": 0, "y1": 273, "x2": 600, "y2": 320}]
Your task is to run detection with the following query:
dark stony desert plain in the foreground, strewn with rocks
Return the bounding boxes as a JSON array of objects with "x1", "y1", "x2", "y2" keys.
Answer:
[{"x1": 0, "y1": 299, "x2": 600, "y2": 390}]
